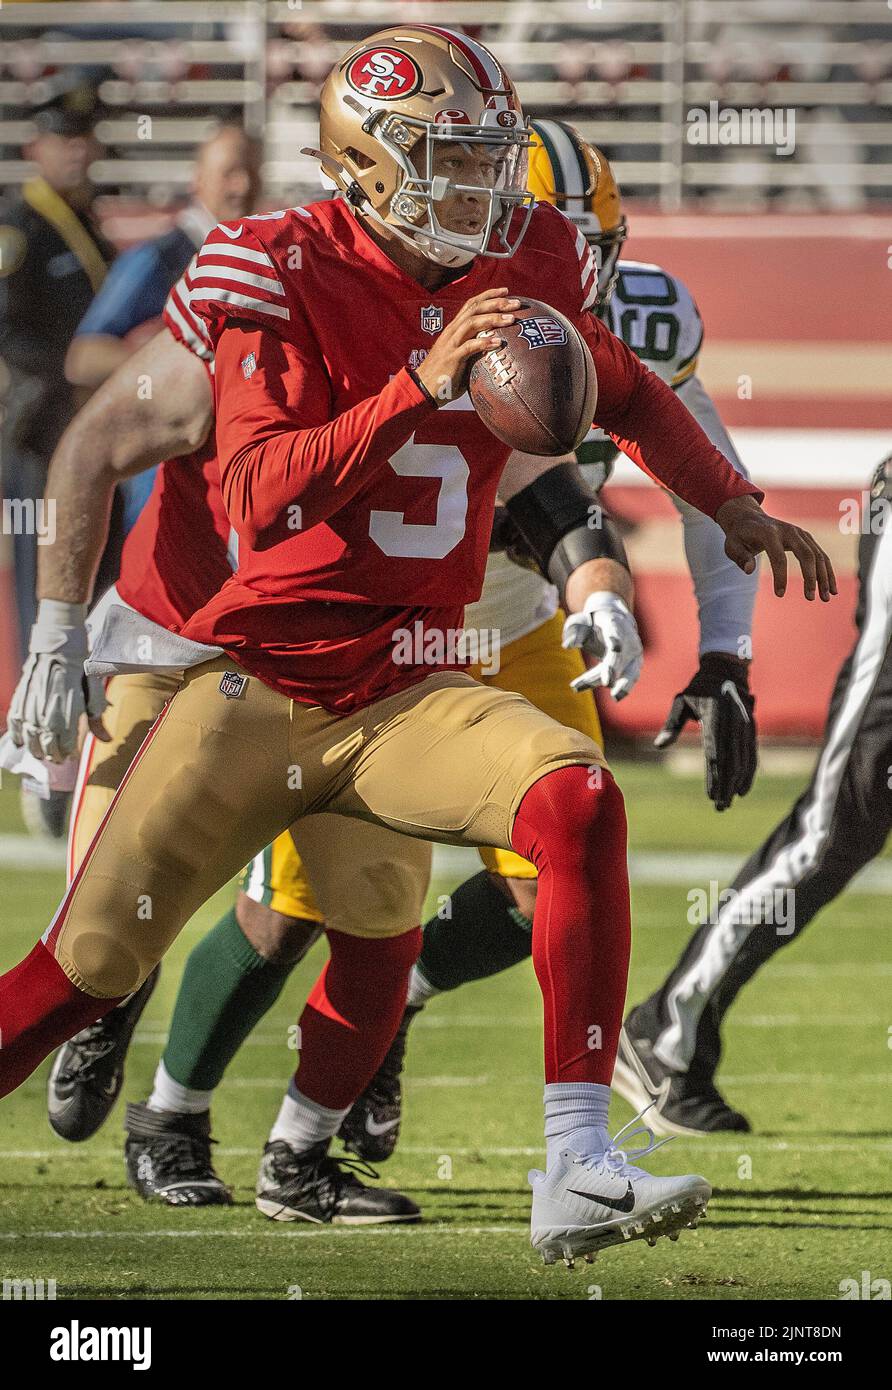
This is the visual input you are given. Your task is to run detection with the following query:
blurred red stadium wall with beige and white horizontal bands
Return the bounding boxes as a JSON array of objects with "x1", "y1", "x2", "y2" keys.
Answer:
[{"x1": 0, "y1": 209, "x2": 892, "y2": 735}]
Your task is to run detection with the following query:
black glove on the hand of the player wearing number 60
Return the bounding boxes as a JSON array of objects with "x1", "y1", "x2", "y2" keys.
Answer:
[{"x1": 654, "y1": 652, "x2": 756, "y2": 810}]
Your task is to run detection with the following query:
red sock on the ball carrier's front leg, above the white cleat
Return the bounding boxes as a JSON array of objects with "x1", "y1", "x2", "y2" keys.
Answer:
[{"x1": 511, "y1": 766, "x2": 631, "y2": 1086}]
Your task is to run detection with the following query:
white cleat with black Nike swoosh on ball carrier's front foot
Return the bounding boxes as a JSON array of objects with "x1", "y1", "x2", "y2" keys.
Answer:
[{"x1": 529, "y1": 1115, "x2": 713, "y2": 1269}]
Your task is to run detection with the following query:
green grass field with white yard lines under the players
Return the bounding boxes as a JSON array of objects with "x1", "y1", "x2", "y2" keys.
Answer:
[{"x1": 0, "y1": 765, "x2": 892, "y2": 1301}]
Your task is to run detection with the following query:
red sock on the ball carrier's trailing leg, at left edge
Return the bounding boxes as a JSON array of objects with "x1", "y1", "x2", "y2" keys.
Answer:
[{"x1": 0, "y1": 941, "x2": 121, "y2": 1095}]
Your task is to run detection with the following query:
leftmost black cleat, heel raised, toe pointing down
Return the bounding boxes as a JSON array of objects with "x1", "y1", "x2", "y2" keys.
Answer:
[{"x1": 46, "y1": 966, "x2": 160, "y2": 1144}]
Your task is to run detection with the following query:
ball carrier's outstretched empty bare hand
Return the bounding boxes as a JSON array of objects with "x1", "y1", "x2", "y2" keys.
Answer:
[{"x1": 716, "y1": 496, "x2": 836, "y2": 603}]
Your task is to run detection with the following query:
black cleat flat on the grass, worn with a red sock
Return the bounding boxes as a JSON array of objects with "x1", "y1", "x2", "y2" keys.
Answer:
[{"x1": 256, "y1": 1138, "x2": 421, "y2": 1226}]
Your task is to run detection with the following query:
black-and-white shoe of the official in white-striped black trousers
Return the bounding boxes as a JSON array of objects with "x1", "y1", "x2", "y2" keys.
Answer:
[{"x1": 613, "y1": 1022, "x2": 750, "y2": 1134}]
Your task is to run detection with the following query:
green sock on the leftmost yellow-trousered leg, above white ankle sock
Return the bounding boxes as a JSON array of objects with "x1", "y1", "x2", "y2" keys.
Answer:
[{"x1": 163, "y1": 908, "x2": 293, "y2": 1091}]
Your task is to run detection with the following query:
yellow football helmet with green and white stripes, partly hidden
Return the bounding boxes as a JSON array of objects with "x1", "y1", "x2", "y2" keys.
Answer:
[{"x1": 528, "y1": 121, "x2": 628, "y2": 304}]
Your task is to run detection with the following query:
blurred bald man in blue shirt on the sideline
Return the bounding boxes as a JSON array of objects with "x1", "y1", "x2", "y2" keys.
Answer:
[{"x1": 65, "y1": 124, "x2": 261, "y2": 539}]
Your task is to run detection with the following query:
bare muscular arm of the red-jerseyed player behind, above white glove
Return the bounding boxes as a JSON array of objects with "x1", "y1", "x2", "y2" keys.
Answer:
[{"x1": 38, "y1": 329, "x2": 213, "y2": 603}]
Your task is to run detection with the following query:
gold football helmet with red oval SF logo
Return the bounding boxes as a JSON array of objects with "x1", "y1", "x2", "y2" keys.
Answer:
[{"x1": 304, "y1": 24, "x2": 535, "y2": 265}]
